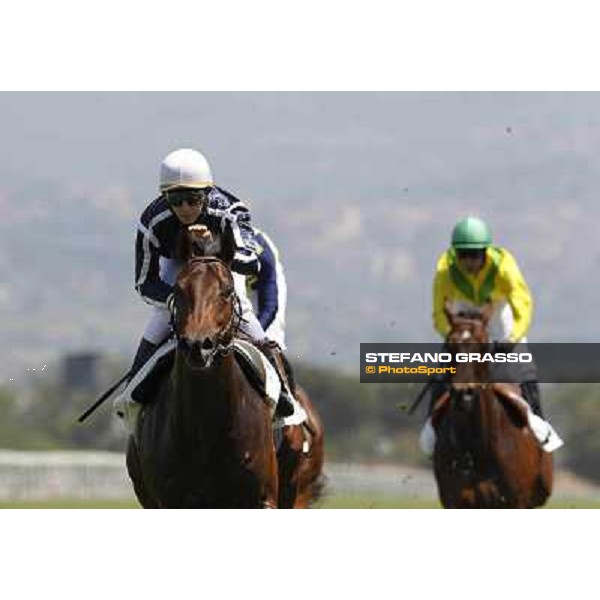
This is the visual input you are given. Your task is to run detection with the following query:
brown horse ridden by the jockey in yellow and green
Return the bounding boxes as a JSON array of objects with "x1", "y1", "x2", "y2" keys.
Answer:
[{"x1": 432, "y1": 305, "x2": 553, "y2": 508}]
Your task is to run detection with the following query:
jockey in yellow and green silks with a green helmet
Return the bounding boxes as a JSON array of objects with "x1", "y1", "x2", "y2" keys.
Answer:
[{"x1": 421, "y1": 217, "x2": 562, "y2": 454}]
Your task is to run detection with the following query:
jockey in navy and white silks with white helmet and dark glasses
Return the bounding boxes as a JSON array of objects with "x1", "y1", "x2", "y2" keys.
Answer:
[{"x1": 119, "y1": 148, "x2": 294, "y2": 417}]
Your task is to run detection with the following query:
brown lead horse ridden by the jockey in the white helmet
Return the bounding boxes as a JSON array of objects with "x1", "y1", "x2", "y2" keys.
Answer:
[{"x1": 127, "y1": 227, "x2": 278, "y2": 508}]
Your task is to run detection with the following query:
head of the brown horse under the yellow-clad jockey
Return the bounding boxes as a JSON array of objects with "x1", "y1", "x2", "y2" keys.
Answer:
[{"x1": 444, "y1": 302, "x2": 494, "y2": 390}]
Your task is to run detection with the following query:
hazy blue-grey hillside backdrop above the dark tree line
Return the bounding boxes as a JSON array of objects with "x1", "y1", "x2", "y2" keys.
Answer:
[{"x1": 0, "y1": 92, "x2": 600, "y2": 381}]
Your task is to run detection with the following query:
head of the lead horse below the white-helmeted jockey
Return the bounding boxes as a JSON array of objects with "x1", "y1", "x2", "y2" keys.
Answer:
[{"x1": 173, "y1": 226, "x2": 239, "y2": 368}]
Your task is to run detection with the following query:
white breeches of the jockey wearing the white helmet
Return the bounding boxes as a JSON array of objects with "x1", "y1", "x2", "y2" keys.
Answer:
[{"x1": 144, "y1": 258, "x2": 266, "y2": 344}]
